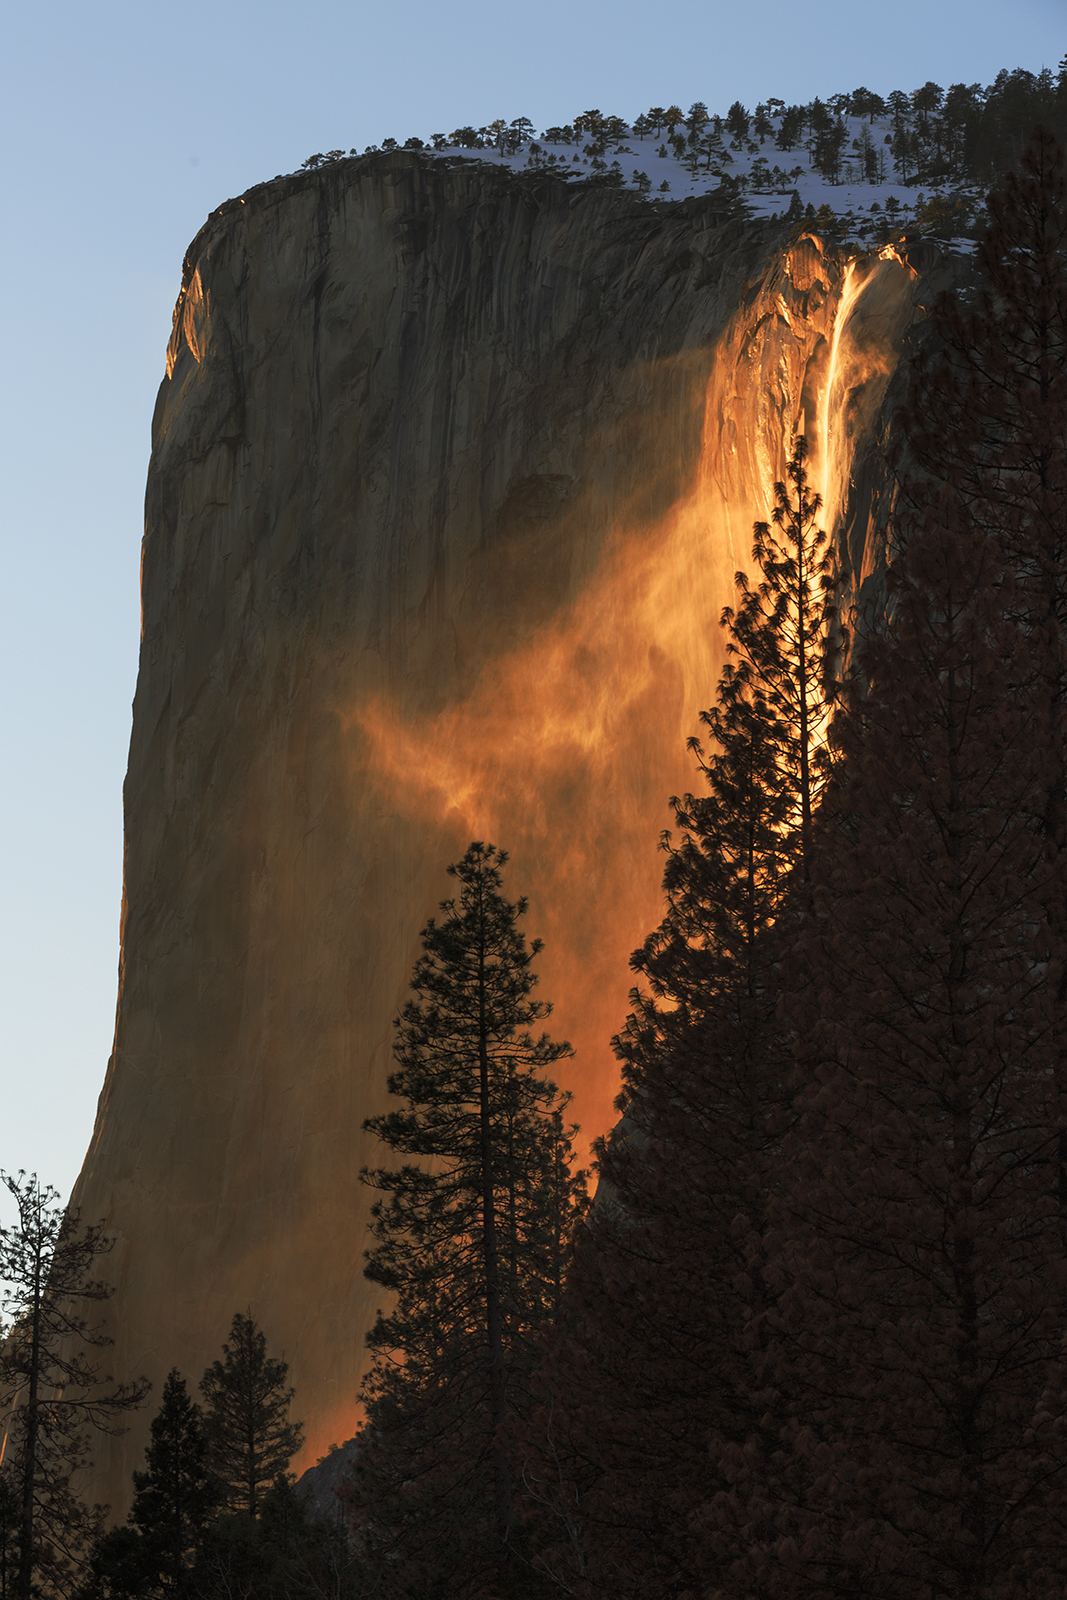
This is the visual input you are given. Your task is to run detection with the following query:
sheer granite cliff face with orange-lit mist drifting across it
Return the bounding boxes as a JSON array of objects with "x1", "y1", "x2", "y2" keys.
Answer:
[{"x1": 74, "y1": 154, "x2": 947, "y2": 1512}]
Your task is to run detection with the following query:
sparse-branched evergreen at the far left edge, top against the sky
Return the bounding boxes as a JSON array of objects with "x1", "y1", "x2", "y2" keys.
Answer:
[{"x1": 0, "y1": 1173, "x2": 149, "y2": 1600}]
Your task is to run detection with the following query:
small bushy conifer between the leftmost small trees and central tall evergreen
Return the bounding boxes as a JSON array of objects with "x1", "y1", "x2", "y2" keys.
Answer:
[{"x1": 200, "y1": 1310, "x2": 304, "y2": 1517}]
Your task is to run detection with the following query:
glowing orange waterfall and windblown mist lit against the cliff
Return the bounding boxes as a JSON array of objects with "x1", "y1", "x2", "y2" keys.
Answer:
[{"x1": 346, "y1": 243, "x2": 921, "y2": 1150}]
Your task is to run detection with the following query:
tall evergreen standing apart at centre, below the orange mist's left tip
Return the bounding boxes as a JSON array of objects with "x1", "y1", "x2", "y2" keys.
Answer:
[{"x1": 355, "y1": 843, "x2": 582, "y2": 1595}]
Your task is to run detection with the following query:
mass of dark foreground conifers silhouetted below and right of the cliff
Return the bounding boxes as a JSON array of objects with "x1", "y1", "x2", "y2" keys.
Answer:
[{"x1": 0, "y1": 130, "x2": 1067, "y2": 1600}]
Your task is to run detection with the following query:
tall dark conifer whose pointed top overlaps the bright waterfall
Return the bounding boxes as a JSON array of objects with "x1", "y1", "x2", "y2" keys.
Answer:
[{"x1": 536, "y1": 440, "x2": 830, "y2": 1600}]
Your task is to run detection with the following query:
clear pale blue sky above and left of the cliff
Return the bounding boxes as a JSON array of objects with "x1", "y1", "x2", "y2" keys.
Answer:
[{"x1": 0, "y1": 0, "x2": 1067, "y2": 1194}]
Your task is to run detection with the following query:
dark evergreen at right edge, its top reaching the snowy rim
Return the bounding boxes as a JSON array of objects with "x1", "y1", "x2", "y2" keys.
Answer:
[{"x1": 904, "y1": 128, "x2": 1067, "y2": 1219}]
